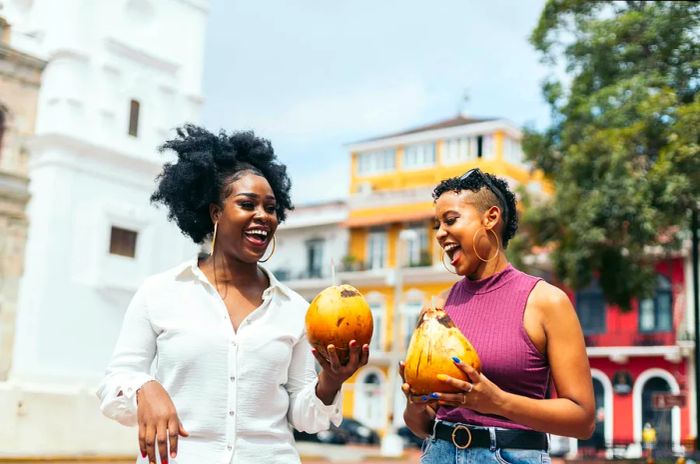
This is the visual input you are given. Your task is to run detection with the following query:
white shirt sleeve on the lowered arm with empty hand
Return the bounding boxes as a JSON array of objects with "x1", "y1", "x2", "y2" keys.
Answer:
[{"x1": 97, "y1": 285, "x2": 157, "y2": 426}]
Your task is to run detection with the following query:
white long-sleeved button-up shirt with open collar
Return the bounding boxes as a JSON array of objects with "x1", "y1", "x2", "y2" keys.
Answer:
[{"x1": 97, "y1": 260, "x2": 342, "y2": 464}]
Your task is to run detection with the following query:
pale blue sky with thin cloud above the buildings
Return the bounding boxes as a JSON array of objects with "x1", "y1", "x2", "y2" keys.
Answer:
[{"x1": 203, "y1": 0, "x2": 549, "y2": 204}]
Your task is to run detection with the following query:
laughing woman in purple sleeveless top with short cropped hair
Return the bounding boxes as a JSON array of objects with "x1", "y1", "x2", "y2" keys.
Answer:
[{"x1": 400, "y1": 169, "x2": 595, "y2": 464}]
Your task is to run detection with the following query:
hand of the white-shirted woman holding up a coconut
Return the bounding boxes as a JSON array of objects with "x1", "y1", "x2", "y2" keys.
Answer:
[{"x1": 311, "y1": 340, "x2": 369, "y2": 404}]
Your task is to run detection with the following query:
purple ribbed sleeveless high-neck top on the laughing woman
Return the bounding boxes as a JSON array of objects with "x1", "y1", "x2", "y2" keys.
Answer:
[{"x1": 437, "y1": 264, "x2": 549, "y2": 430}]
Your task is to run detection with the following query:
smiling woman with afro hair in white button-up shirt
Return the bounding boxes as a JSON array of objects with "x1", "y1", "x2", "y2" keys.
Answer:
[{"x1": 98, "y1": 125, "x2": 369, "y2": 464}]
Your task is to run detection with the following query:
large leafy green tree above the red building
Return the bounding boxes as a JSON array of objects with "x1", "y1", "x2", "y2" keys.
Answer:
[{"x1": 516, "y1": 0, "x2": 700, "y2": 308}]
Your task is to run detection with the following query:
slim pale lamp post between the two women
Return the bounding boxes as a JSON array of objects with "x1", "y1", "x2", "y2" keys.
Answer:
[{"x1": 381, "y1": 229, "x2": 418, "y2": 456}]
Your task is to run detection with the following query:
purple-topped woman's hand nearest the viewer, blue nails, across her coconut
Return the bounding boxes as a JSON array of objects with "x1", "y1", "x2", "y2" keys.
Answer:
[{"x1": 430, "y1": 360, "x2": 504, "y2": 414}]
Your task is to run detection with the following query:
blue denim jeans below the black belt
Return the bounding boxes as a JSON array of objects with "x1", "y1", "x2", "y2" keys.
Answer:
[{"x1": 420, "y1": 424, "x2": 552, "y2": 464}]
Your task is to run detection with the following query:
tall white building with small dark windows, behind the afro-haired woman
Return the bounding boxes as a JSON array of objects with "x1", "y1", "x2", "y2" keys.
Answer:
[{"x1": 0, "y1": 0, "x2": 208, "y2": 455}]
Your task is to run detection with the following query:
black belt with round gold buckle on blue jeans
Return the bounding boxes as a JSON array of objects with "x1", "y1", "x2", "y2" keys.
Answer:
[{"x1": 435, "y1": 421, "x2": 549, "y2": 451}]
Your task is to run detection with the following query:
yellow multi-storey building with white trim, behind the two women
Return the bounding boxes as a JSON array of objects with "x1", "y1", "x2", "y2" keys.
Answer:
[{"x1": 339, "y1": 116, "x2": 542, "y2": 431}]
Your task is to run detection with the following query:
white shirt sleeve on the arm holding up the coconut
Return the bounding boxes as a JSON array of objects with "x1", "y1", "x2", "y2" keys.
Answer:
[{"x1": 286, "y1": 335, "x2": 343, "y2": 433}]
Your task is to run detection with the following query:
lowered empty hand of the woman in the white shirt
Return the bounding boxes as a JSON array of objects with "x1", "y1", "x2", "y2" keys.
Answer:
[{"x1": 136, "y1": 381, "x2": 189, "y2": 464}]
